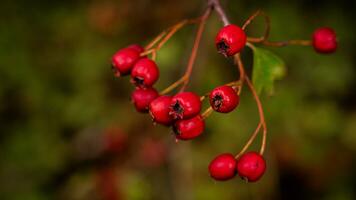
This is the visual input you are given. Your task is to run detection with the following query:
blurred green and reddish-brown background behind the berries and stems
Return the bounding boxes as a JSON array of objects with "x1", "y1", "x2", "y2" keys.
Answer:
[{"x1": 0, "y1": 0, "x2": 356, "y2": 200}]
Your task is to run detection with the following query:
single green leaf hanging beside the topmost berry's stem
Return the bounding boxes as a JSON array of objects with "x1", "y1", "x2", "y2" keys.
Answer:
[{"x1": 251, "y1": 46, "x2": 286, "y2": 95}]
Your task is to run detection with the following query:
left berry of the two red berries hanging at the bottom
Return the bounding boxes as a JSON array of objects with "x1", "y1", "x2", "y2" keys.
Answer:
[{"x1": 209, "y1": 153, "x2": 236, "y2": 181}]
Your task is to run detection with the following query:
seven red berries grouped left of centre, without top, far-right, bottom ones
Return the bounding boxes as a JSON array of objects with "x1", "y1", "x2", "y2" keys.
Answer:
[{"x1": 112, "y1": 45, "x2": 239, "y2": 140}]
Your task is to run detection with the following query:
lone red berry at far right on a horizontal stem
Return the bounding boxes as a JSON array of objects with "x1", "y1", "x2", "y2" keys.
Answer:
[{"x1": 313, "y1": 27, "x2": 337, "y2": 53}]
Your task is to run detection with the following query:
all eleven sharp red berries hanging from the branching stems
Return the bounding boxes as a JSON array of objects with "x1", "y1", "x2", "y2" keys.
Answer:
[{"x1": 112, "y1": 21, "x2": 337, "y2": 182}]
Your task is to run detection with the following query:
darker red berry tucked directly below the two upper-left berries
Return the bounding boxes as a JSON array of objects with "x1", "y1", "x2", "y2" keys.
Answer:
[{"x1": 131, "y1": 88, "x2": 158, "y2": 113}]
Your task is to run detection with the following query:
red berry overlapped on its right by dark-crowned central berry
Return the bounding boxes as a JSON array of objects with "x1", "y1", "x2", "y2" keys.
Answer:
[{"x1": 149, "y1": 96, "x2": 173, "y2": 126}]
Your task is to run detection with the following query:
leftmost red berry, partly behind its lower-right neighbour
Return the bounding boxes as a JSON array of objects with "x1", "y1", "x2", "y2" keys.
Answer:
[{"x1": 111, "y1": 48, "x2": 140, "y2": 77}]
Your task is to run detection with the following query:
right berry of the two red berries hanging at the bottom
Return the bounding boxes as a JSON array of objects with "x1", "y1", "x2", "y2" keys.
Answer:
[{"x1": 237, "y1": 152, "x2": 266, "y2": 182}]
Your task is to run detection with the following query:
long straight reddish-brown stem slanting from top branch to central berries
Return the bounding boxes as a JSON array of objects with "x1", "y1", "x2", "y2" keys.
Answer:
[{"x1": 180, "y1": 7, "x2": 212, "y2": 92}]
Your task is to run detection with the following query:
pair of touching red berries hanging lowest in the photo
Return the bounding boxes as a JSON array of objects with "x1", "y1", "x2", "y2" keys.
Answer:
[{"x1": 209, "y1": 152, "x2": 266, "y2": 182}]
